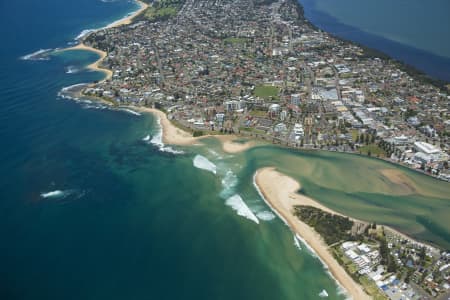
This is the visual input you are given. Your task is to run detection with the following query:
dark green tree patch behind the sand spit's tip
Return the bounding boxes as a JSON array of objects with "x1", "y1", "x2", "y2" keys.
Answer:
[{"x1": 294, "y1": 205, "x2": 353, "y2": 245}]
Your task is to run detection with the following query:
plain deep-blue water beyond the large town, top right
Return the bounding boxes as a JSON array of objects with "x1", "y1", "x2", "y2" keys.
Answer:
[{"x1": 298, "y1": 0, "x2": 450, "y2": 82}]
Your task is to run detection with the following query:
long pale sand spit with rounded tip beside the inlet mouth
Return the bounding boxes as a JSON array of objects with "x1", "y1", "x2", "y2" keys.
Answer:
[{"x1": 255, "y1": 168, "x2": 371, "y2": 300}]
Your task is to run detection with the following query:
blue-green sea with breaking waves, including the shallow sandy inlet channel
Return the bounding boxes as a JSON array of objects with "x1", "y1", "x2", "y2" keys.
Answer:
[{"x1": 0, "y1": 0, "x2": 450, "y2": 299}]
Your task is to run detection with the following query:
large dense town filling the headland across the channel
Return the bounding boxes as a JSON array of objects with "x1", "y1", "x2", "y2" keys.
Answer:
[{"x1": 79, "y1": 0, "x2": 450, "y2": 181}]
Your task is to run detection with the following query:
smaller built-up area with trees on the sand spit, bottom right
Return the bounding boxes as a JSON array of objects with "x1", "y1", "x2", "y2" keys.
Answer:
[{"x1": 294, "y1": 206, "x2": 450, "y2": 300}]
